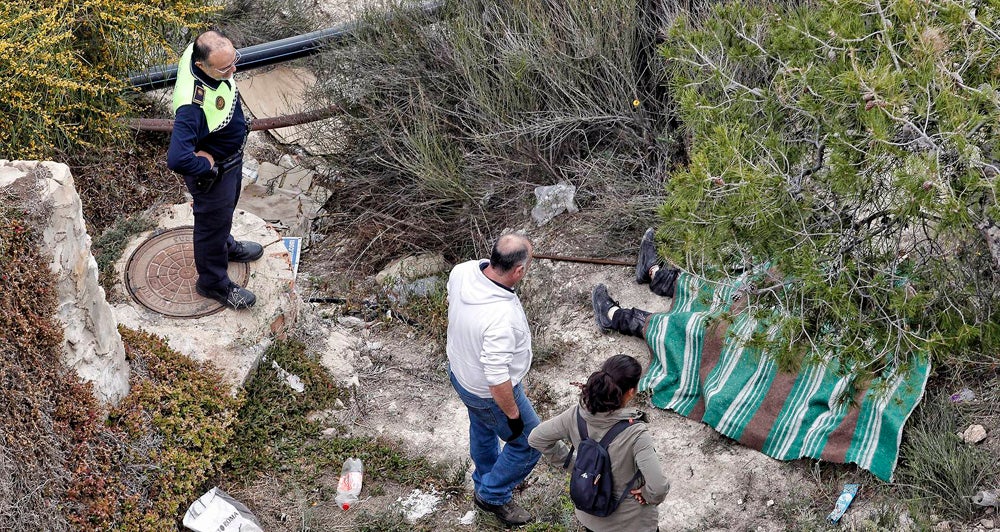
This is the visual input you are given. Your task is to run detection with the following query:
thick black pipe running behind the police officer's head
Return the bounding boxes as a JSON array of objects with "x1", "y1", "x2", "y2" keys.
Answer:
[{"x1": 129, "y1": 2, "x2": 443, "y2": 92}]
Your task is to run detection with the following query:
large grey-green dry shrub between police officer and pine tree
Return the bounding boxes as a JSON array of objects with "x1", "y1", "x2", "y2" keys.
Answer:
[{"x1": 308, "y1": 0, "x2": 671, "y2": 268}]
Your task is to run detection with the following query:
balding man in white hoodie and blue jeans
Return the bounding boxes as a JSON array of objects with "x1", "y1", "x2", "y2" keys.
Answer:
[{"x1": 447, "y1": 234, "x2": 541, "y2": 526}]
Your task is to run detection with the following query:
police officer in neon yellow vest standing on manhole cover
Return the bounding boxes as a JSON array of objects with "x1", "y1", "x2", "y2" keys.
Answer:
[{"x1": 167, "y1": 30, "x2": 264, "y2": 309}]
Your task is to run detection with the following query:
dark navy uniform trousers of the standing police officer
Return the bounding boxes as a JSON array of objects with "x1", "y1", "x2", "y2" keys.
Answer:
[{"x1": 184, "y1": 154, "x2": 243, "y2": 289}]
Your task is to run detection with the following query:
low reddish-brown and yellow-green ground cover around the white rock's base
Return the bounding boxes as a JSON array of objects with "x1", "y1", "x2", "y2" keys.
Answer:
[{"x1": 0, "y1": 196, "x2": 239, "y2": 530}]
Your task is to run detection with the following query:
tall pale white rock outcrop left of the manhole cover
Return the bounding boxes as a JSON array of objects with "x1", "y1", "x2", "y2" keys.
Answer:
[{"x1": 0, "y1": 161, "x2": 129, "y2": 404}]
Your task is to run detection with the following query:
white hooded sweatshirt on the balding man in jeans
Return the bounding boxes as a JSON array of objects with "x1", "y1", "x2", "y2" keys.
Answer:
[{"x1": 447, "y1": 260, "x2": 531, "y2": 398}]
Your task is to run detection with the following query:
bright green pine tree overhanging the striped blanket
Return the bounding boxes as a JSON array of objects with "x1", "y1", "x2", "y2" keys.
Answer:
[{"x1": 659, "y1": 0, "x2": 1000, "y2": 374}]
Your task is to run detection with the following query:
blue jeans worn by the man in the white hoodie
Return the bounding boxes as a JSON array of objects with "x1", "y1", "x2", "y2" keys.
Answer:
[{"x1": 448, "y1": 370, "x2": 542, "y2": 505}]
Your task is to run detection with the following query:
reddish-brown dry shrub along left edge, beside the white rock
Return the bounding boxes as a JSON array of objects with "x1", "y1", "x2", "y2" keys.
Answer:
[{"x1": 0, "y1": 190, "x2": 112, "y2": 530}]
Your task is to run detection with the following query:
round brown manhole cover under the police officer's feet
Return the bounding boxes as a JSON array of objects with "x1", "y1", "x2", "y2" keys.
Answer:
[{"x1": 125, "y1": 225, "x2": 250, "y2": 318}]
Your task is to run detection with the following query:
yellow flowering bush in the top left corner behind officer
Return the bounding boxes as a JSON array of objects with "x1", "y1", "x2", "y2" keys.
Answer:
[{"x1": 0, "y1": 0, "x2": 218, "y2": 159}]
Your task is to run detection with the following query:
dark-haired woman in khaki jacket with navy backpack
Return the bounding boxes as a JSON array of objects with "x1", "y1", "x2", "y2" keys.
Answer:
[{"x1": 528, "y1": 355, "x2": 670, "y2": 532}]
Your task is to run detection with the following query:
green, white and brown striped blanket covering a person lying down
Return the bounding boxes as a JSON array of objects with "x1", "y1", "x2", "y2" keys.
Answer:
[{"x1": 639, "y1": 274, "x2": 930, "y2": 481}]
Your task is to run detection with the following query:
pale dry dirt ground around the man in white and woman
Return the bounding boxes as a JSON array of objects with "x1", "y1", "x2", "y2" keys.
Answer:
[{"x1": 232, "y1": 215, "x2": 864, "y2": 530}]
